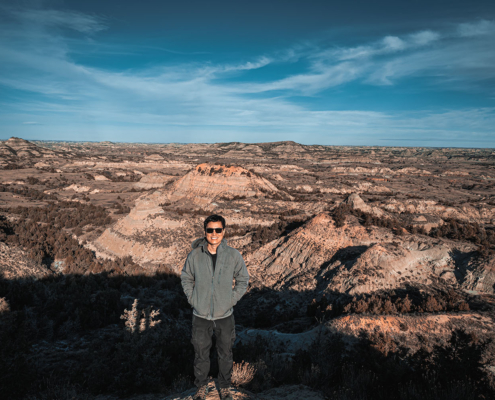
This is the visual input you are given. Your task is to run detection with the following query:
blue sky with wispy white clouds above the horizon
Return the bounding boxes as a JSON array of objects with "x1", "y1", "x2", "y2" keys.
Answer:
[{"x1": 0, "y1": 0, "x2": 495, "y2": 147}]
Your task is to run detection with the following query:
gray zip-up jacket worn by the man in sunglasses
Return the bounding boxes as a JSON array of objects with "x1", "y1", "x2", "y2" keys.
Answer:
[{"x1": 180, "y1": 238, "x2": 249, "y2": 320}]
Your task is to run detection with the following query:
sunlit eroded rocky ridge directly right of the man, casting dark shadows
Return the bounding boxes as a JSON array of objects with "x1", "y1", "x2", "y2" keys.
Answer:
[{"x1": 248, "y1": 213, "x2": 495, "y2": 294}]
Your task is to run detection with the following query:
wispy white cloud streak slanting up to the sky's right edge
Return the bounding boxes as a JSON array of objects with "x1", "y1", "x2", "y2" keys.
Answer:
[{"x1": 244, "y1": 21, "x2": 495, "y2": 95}]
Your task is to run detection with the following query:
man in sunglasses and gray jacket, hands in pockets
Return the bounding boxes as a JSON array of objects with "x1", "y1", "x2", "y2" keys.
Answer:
[{"x1": 181, "y1": 215, "x2": 249, "y2": 400}]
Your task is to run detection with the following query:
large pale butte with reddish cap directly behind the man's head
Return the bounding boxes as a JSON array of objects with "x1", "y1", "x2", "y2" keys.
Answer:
[{"x1": 92, "y1": 164, "x2": 289, "y2": 271}]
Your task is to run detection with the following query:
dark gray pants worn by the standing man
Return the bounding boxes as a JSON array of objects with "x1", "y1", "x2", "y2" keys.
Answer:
[{"x1": 191, "y1": 314, "x2": 235, "y2": 388}]
